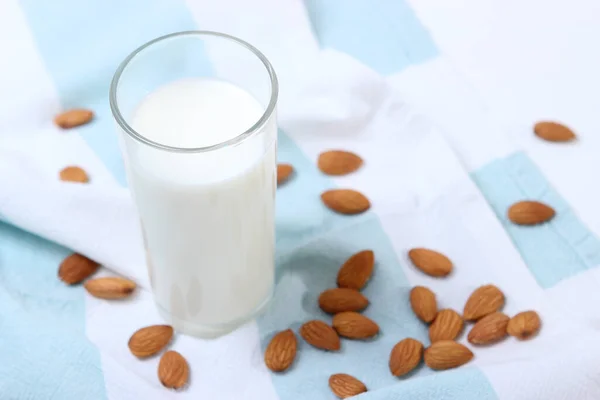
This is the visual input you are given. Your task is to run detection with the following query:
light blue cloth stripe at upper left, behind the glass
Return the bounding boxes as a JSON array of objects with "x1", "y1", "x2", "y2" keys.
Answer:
[{"x1": 21, "y1": 0, "x2": 196, "y2": 185}]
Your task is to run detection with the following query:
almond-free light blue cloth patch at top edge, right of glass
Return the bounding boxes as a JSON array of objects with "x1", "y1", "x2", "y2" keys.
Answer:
[{"x1": 305, "y1": 0, "x2": 438, "y2": 75}]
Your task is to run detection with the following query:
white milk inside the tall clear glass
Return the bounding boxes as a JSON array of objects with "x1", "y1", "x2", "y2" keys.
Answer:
[{"x1": 125, "y1": 79, "x2": 277, "y2": 337}]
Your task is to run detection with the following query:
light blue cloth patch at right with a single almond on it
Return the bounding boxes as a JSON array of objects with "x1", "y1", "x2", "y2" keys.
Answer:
[{"x1": 473, "y1": 152, "x2": 600, "y2": 288}]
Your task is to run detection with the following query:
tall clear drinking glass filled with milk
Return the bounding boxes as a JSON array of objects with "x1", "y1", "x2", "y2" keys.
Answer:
[{"x1": 110, "y1": 32, "x2": 278, "y2": 337}]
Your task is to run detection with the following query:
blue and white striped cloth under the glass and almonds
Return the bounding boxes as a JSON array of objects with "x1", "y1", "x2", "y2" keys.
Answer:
[{"x1": 0, "y1": 0, "x2": 600, "y2": 400}]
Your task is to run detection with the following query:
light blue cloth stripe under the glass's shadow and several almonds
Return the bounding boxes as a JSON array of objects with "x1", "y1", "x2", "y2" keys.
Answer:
[{"x1": 258, "y1": 135, "x2": 496, "y2": 400}]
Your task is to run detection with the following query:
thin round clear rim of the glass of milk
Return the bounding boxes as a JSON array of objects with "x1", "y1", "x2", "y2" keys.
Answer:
[{"x1": 109, "y1": 31, "x2": 279, "y2": 153}]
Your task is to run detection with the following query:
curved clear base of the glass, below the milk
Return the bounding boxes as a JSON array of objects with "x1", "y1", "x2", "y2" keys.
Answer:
[{"x1": 155, "y1": 291, "x2": 273, "y2": 339}]
